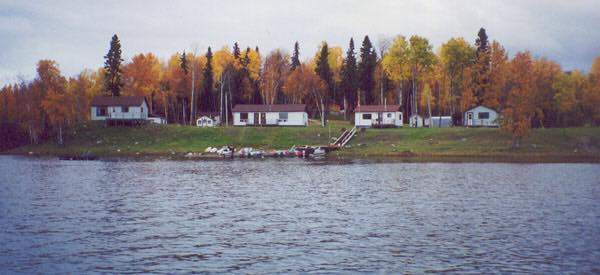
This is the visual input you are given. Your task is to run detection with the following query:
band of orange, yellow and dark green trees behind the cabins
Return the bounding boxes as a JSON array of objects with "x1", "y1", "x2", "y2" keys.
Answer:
[{"x1": 0, "y1": 28, "x2": 600, "y2": 148}]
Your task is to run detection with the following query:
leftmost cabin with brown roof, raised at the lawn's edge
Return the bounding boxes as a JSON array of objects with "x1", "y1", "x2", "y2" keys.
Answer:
[{"x1": 91, "y1": 96, "x2": 148, "y2": 120}]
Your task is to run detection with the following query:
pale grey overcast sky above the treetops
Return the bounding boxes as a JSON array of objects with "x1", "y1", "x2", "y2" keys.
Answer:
[{"x1": 0, "y1": 0, "x2": 600, "y2": 85}]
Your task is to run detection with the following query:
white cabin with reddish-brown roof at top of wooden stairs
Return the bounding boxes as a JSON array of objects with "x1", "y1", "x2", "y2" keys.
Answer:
[{"x1": 354, "y1": 105, "x2": 403, "y2": 128}]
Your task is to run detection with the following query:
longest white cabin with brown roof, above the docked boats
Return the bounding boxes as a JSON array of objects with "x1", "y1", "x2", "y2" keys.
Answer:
[{"x1": 232, "y1": 104, "x2": 308, "y2": 126}]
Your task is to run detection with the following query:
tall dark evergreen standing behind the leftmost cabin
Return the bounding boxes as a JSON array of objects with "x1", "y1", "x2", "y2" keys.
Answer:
[{"x1": 104, "y1": 34, "x2": 123, "y2": 96}]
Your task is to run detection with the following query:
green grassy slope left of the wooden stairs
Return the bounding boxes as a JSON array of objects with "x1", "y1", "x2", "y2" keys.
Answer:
[{"x1": 10, "y1": 121, "x2": 352, "y2": 156}]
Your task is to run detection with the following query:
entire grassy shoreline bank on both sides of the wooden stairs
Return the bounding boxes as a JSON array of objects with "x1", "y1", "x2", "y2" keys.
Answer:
[{"x1": 9, "y1": 121, "x2": 600, "y2": 159}]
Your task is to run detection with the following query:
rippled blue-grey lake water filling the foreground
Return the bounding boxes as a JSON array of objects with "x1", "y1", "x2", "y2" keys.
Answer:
[{"x1": 0, "y1": 156, "x2": 600, "y2": 274}]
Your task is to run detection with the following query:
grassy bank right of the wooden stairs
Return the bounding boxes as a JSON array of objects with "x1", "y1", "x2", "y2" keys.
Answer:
[{"x1": 340, "y1": 127, "x2": 600, "y2": 156}]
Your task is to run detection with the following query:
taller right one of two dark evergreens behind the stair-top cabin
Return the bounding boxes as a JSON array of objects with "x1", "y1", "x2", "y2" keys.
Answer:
[{"x1": 357, "y1": 35, "x2": 377, "y2": 104}]
